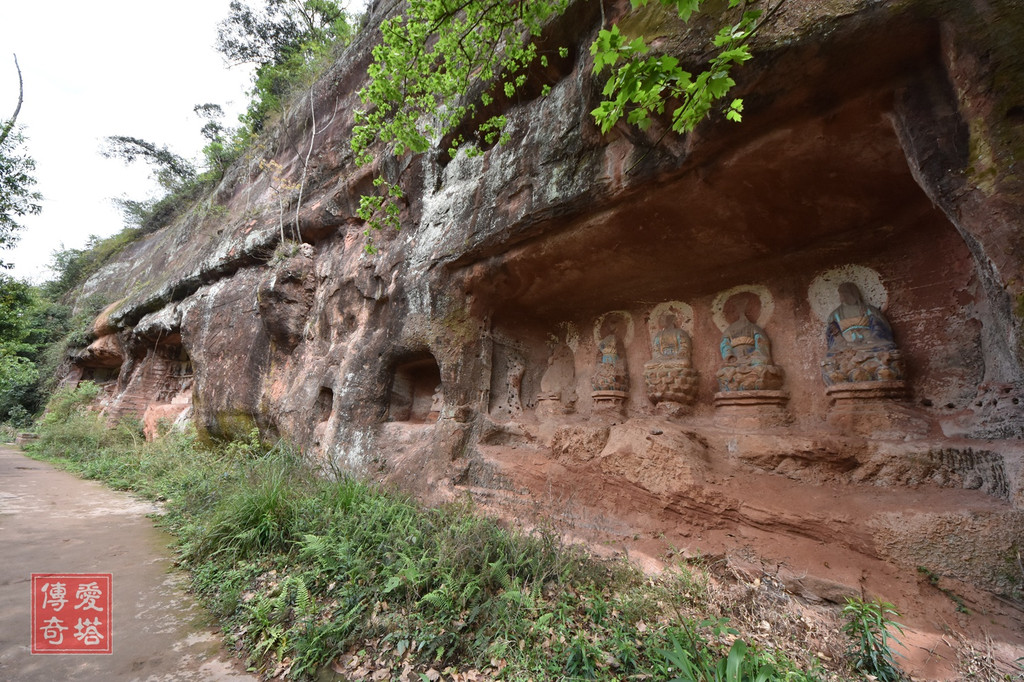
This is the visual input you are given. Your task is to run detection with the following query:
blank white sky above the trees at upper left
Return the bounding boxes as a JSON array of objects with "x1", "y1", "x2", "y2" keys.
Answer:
[{"x1": 0, "y1": 0, "x2": 286, "y2": 283}]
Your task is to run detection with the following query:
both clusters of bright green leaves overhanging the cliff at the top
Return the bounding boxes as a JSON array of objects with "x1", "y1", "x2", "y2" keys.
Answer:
[{"x1": 352, "y1": 0, "x2": 784, "y2": 241}]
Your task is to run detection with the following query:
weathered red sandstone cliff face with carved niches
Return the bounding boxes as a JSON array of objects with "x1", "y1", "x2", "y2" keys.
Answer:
[{"x1": 68, "y1": 0, "x2": 1024, "y2": 677}]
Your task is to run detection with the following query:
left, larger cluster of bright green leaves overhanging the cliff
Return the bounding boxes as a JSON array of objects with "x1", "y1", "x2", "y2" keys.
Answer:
[{"x1": 352, "y1": 0, "x2": 570, "y2": 236}]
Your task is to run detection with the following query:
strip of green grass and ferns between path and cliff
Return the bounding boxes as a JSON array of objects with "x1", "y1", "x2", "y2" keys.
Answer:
[{"x1": 32, "y1": 387, "x2": 837, "y2": 682}]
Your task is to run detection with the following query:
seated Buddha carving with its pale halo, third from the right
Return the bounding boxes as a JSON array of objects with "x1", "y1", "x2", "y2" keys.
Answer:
[{"x1": 643, "y1": 301, "x2": 698, "y2": 406}]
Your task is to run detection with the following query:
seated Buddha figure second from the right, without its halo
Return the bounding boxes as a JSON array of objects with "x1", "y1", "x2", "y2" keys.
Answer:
[{"x1": 717, "y1": 299, "x2": 783, "y2": 392}]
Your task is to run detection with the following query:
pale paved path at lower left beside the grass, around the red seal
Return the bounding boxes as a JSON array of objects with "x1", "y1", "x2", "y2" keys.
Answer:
[{"x1": 0, "y1": 446, "x2": 257, "y2": 682}]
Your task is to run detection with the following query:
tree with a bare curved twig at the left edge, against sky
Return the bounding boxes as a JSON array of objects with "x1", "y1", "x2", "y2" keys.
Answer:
[{"x1": 0, "y1": 55, "x2": 42, "y2": 267}]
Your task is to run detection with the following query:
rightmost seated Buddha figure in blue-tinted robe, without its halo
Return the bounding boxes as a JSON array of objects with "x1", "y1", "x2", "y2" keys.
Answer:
[{"x1": 821, "y1": 282, "x2": 904, "y2": 386}]
